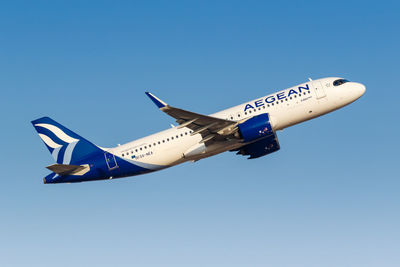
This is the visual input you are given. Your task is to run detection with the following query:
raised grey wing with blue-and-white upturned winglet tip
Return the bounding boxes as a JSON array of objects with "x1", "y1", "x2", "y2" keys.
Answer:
[{"x1": 146, "y1": 92, "x2": 238, "y2": 143}]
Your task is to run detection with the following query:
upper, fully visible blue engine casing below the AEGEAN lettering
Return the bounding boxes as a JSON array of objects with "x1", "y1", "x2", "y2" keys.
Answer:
[{"x1": 238, "y1": 113, "x2": 274, "y2": 142}]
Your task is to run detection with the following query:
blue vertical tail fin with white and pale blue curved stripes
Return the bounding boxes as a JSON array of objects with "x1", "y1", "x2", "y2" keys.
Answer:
[{"x1": 32, "y1": 117, "x2": 102, "y2": 165}]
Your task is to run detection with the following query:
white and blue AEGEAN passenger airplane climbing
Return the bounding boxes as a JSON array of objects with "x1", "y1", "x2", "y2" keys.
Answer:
[{"x1": 32, "y1": 77, "x2": 366, "y2": 184}]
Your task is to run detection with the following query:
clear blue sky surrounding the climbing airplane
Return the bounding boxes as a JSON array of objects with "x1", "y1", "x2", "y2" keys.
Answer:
[{"x1": 0, "y1": 1, "x2": 400, "y2": 267}]
